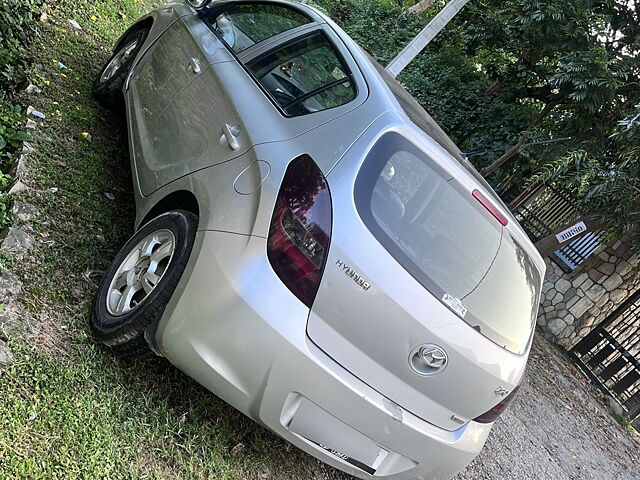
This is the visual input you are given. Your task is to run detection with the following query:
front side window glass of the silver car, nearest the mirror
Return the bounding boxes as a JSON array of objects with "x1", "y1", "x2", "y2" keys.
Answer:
[{"x1": 213, "y1": 3, "x2": 311, "y2": 53}]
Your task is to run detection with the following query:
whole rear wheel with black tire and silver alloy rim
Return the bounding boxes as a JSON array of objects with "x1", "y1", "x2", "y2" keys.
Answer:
[{"x1": 91, "y1": 210, "x2": 198, "y2": 356}]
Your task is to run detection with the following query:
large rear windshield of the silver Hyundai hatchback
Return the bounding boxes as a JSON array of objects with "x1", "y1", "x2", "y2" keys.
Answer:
[{"x1": 355, "y1": 133, "x2": 541, "y2": 353}]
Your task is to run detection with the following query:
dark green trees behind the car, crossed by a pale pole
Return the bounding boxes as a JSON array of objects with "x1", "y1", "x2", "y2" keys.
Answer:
[{"x1": 321, "y1": 0, "x2": 640, "y2": 202}]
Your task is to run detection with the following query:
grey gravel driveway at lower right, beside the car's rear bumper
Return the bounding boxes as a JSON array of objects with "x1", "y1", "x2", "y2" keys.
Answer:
[{"x1": 456, "y1": 335, "x2": 640, "y2": 480}]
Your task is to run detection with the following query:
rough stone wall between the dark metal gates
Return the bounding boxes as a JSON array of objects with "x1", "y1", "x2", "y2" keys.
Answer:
[{"x1": 538, "y1": 240, "x2": 640, "y2": 348}]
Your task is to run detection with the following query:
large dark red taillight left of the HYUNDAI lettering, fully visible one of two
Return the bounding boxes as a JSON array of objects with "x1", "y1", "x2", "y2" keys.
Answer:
[{"x1": 267, "y1": 155, "x2": 331, "y2": 308}]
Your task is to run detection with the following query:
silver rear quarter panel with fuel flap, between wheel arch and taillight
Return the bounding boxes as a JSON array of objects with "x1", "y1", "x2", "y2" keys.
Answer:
[{"x1": 136, "y1": 102, "x2": 382, "y2": 237}]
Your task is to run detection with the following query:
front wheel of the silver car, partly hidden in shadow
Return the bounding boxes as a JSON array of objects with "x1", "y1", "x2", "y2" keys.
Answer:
[{"x1": 92, "y1": 28, "x2": 149, "y2": 110}]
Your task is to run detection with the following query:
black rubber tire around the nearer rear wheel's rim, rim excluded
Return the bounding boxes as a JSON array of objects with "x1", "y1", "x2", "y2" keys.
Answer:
[{"x1": 91, "y1": 210, "x2": 197, "y2": 343}]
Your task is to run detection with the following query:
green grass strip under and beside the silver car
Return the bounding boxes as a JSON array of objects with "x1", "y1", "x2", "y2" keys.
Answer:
[{"x1": 0, "y1": 0, "x2": 339, "y2": 479}]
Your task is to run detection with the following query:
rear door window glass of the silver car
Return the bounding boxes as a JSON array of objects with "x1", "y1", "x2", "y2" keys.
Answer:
[{"x1": 247, "y1": 32, "x2": 356, "y2": 116}]
